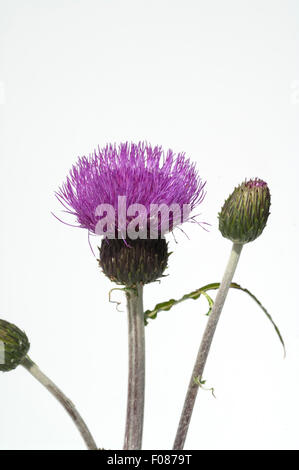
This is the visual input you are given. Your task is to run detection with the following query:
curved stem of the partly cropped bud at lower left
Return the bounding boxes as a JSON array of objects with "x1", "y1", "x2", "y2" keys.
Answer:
[{"x1": 22, "y1": 356, "x2": 97, "y2": 450}]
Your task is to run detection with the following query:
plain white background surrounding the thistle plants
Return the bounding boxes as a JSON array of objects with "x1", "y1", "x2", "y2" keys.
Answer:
[{"x1": 0, "y1": 0, "x2": 299, "y2": 449}]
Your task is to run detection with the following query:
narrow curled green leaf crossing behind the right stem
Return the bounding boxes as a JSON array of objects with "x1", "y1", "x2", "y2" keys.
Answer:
[{"x1": 144, "y1": 282, "x2": 286, "y2": 356}]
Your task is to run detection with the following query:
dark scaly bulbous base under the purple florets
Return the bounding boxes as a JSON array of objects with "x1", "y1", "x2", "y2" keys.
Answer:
[{"x1": 98, "y1": 238, "x2": 169, "y2": 287}]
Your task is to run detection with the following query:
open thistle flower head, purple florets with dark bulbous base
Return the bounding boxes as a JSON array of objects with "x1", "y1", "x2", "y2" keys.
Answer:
[{"x1": 56, "y1": 142, "x2": 205, "y2": 285}]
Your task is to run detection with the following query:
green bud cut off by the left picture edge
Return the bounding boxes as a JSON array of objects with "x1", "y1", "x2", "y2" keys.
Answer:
[{"x1": 0, "y1": 320, "x2": 30, "y2": 372}]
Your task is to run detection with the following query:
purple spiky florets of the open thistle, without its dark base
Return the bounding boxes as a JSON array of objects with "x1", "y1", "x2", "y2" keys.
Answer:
[{"x1": 56, "y1": 142, "x2": 205, "y2": 239}]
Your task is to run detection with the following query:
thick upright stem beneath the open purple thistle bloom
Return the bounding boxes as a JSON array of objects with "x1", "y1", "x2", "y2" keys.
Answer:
[{"x1": 123, "y1": 284, "x2": 145, "y2": 450}]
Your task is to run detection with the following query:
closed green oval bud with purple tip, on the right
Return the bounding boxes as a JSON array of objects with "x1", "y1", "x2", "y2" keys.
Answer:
[{"x1": 219, "y1": 178, "x2": 270, "y2": 244}]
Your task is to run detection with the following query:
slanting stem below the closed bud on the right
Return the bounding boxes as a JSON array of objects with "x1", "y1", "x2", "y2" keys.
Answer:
[{"x1": 173, "y1": 243, "x2": 243, "y2": 450}]
